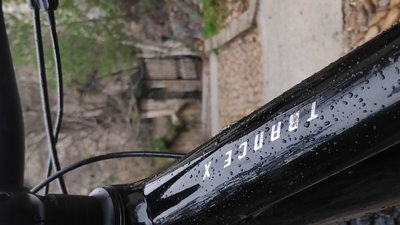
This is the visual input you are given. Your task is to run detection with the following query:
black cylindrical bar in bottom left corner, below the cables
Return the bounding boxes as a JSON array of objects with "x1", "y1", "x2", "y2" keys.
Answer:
[{"x1": 0, "y1": 190, "x2": 104, "y2": 225}]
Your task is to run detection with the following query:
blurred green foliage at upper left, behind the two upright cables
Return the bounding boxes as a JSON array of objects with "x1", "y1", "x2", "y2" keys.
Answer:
[{"x1": 3, "y1": 0, "x2": 136, "y2": 88}]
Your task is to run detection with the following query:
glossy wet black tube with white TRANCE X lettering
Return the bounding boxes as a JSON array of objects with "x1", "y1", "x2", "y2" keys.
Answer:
[{"x1": 122, "y1": 23, "x2": 400, "y2": 224}]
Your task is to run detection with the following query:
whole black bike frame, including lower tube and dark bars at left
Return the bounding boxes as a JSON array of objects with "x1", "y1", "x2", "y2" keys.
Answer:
[{"x1": 0, "y1": 0, "x2": 400, "y2": 224}]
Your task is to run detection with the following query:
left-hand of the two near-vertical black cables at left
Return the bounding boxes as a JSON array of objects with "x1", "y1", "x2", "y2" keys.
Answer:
[{"x1": 33, "y1": 8, "x2": 68, "y2": 194}]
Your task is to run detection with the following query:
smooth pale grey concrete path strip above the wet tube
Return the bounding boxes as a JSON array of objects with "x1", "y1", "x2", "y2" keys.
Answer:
[{"x1": 257, "y1": 0, "x2": 343, "y2": 102}]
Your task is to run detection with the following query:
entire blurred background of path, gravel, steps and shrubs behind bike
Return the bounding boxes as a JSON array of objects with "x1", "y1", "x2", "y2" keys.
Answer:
[{"x1": 3, "y1": 0, "x2": 400, "y2": 224}]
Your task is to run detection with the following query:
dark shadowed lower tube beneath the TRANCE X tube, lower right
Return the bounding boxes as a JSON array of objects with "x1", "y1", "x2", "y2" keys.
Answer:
[{"x1": 251, "y1": 145, "x2": 400, "y2": 225}]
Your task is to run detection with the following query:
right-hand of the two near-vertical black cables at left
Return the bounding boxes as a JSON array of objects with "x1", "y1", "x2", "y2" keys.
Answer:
[{"x1": 44, "y1": 10, "x2": 64, "y2": 195}]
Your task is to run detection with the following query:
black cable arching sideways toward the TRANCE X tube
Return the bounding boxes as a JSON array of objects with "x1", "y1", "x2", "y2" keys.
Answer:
[{"x1": 31, "y1": 151, "x2": 185, "y2": 194}]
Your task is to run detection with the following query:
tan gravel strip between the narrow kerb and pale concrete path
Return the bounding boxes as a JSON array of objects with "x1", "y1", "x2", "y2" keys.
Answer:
[{"x1": 217, "y1": 28, "x2": 265, "y2": 128}]
